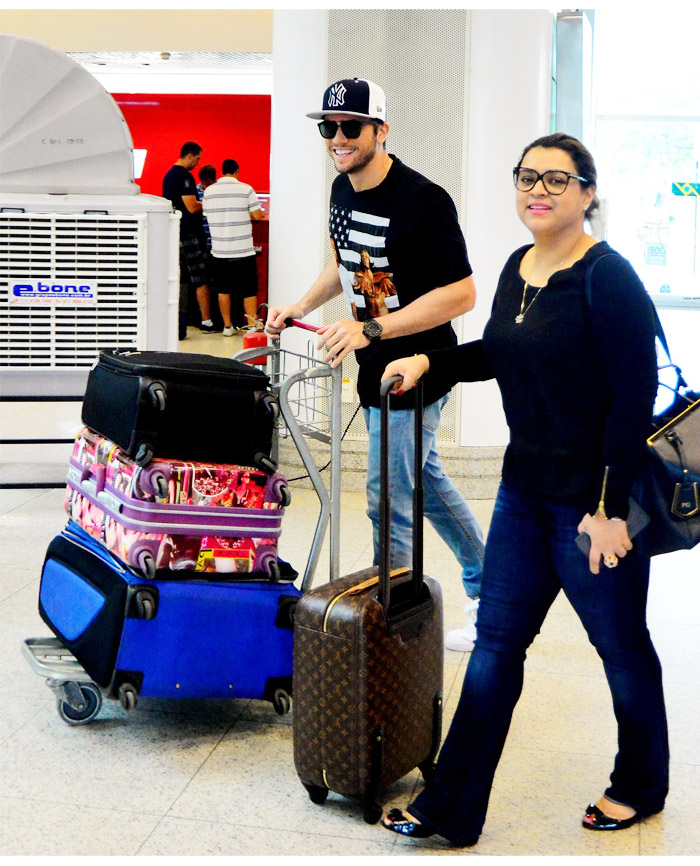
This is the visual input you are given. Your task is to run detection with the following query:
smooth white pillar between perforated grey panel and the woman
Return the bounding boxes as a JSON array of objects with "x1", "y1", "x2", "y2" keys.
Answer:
[{"x1": 460, "y1": 10, "x2": 553, "y2": 446}]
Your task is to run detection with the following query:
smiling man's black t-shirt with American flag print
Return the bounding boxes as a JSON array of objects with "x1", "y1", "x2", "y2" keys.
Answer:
[{"x1": 329, "y1": 156, "x2": 472, "y2": 409}]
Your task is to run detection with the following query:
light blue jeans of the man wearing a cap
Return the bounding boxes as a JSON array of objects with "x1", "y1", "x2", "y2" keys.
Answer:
[{"x1": 364, "y1": 397, "x2": 484, "y2": 598}]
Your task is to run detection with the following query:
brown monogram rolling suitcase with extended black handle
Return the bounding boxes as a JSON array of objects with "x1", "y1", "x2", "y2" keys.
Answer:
[{"x1": 293, "y1": 381, "x2": 443, "y2": 823}]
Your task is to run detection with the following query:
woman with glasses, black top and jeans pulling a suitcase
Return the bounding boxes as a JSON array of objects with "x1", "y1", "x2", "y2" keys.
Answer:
[{"x1": 383, "y1": 133, "x2": 669, "y2": 846}]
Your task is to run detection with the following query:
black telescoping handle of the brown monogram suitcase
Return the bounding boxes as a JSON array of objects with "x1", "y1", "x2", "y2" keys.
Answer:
[{"x1": 378, "y1": 376, "x2": 423, "y2": 614}]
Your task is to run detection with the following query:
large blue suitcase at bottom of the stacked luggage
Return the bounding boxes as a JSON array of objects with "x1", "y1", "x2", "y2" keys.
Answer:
[{"x1": 39, "y1": 521, "x2": 301, "y2": 721}]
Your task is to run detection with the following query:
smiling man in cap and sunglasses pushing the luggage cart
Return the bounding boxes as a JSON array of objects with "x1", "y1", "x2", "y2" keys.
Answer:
[{"x1": 267, "y1": 78, "x2": 483, "y2": 651}]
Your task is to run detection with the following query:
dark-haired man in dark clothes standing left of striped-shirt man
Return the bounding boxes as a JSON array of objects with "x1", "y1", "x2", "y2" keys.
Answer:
[{"x1": 163, "y1": 141, "x2": 217, "y2": 340}]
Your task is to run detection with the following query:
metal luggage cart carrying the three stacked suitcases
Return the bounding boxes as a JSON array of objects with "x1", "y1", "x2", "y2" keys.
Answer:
[{"x1": 22, "y1": 344, "x2": 342, "y2": 725}]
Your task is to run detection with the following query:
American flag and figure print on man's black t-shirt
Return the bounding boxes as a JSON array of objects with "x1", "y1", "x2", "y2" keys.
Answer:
[{"x1": 328, "y1": 204, "x2": 401, "y2": 322}]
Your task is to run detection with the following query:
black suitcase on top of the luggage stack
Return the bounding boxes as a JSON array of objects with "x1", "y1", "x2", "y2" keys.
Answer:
[{"x1": 82, "y1": 351, "x2": 277, "y2": 471}]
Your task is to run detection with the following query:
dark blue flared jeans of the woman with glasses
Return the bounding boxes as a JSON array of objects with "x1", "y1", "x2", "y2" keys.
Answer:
[{"x1": 409, "y1": 483, "x2": 669, "y2": 845}]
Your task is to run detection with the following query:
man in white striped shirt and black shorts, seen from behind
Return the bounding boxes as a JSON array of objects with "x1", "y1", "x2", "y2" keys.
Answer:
[{"x1": 202, "y1": 159, "x2": 263, "y2": 337}]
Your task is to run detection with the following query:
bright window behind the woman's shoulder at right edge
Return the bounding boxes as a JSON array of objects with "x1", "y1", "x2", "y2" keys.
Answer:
[{"x1": 594, "y1": 6, "x2": 700, "y2": 307}]
